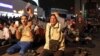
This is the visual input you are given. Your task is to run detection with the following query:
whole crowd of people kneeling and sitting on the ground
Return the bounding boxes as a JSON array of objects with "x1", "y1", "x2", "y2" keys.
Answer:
[{"x1": 0, "y1": 7, "x2": 99, "y2": 56}]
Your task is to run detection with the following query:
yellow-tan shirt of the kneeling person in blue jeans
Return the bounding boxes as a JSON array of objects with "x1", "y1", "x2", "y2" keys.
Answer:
[{"x1": 18, "y1": 26, "x2": 33, "y2": 42}]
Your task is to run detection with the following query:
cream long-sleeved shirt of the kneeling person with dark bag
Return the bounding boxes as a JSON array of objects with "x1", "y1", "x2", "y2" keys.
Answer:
[{"x1": 44, "y1": 23, "x2": 65, "y2": 51}]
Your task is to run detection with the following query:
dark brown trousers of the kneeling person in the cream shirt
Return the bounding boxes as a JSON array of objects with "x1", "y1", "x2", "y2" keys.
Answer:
[{"x1": 40, "y1": 49, "x2": 64, "y2": 56}]
